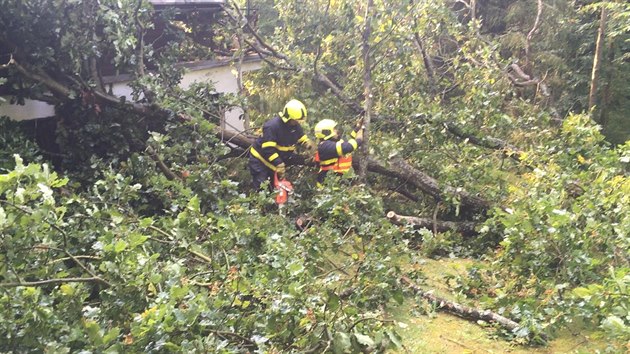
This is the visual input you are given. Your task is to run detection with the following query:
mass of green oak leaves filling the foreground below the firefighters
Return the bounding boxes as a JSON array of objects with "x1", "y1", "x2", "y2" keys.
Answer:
[{"x1": 0, "y1": 154, "x2": 402, "y2": 352}]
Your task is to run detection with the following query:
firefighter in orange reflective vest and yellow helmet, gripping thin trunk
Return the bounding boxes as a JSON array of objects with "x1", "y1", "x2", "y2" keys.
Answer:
[{"x1": 315, "y1": 119, "x2": 363, "y2": 186}]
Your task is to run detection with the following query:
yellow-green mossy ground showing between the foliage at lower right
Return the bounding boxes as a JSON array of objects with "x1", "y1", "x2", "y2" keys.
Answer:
[{"x1": 391, "y1": 259, "x2": 606, "y2": 354}]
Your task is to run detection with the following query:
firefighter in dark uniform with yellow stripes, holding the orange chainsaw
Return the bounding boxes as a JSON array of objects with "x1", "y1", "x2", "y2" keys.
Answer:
[{"x1": 248, "y1": 99, "x2": 315, "y2": 190}]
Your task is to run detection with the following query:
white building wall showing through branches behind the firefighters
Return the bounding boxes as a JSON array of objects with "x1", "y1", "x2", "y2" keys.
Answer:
[{"x1": 0, "y1": 60, "x2": 261, "y2": 131}]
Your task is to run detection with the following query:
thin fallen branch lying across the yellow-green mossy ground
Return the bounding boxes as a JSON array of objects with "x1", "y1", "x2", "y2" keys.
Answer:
[{"x1": 400, "y1": 276, "x2": 521, "y2": 333}]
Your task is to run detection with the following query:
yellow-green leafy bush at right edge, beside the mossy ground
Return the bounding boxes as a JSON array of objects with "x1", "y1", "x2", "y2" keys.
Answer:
[{"x1": 474, "y1": 115, "x2": 630, "y2": 342}]
